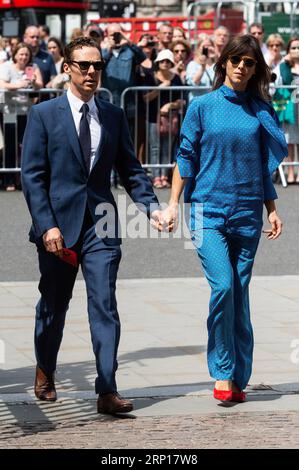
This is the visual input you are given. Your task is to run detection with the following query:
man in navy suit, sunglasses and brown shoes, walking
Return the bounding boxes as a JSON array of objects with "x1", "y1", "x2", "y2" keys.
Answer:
[{"x1": 22, "y1": 38, "x2": 160, "y2": 414}]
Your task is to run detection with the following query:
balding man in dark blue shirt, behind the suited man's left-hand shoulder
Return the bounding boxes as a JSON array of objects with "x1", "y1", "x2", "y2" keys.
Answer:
[{"x1": 24, "y1": 26, "x2": 57, "y2": 87}]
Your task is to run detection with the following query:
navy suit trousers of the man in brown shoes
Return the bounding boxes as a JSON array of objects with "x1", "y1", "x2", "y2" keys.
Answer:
[{"x1": 35, "y1": 212, "x2": 121, "y2": 394}]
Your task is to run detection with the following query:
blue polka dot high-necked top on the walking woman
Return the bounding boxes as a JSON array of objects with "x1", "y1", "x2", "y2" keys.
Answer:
[{"x1": 177, "y1": 85, "x2": 277, "y2": 237}]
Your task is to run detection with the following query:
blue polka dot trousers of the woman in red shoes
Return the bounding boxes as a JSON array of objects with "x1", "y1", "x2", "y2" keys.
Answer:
[{"x1": 197, "y1": 229, "x2": 259, "y2": 390}]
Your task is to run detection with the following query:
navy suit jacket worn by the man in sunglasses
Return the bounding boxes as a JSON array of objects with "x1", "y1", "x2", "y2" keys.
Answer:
[{"x1": 22, "y1": 94, "x2": 158, "y2": 247}]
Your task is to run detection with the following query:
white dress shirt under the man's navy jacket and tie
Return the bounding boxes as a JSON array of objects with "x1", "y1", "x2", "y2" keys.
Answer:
[{"x1": 67, "y1": 88, "x2": 102, "y2": 171}]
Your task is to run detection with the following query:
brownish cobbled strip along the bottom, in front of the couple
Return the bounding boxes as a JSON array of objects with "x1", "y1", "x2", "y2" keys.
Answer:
[{"x1": 0, "y1": 411, "x2": 299, "y2": 449}]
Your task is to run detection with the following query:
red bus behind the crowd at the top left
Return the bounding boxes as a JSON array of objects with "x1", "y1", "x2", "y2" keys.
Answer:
[{"x1": 0, "y1": 0, "x2": 89, "y2": 41}]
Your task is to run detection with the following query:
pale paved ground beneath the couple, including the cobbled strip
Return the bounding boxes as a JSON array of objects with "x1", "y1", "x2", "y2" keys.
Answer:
[{"x1": 0, "y1": 276, "x2": 299, "y2": 449}]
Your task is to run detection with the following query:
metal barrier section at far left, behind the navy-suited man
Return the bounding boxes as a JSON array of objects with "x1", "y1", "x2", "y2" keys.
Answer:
[{"x1": 0, "y1": 88, "x2": 113, "y2": 173}]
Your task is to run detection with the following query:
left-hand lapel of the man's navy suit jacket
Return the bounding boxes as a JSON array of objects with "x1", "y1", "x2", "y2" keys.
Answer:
[{"x1": 58, "y1": 93, "x2": 87, "y2": 173}]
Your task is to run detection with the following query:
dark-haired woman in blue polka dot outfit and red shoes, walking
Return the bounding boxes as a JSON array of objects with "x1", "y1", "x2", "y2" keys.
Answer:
[{"x1": 163, "y1": 35, "x2": 287, "y2": 402}]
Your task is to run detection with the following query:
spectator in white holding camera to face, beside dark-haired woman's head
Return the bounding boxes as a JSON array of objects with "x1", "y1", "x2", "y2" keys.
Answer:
[{"x1": 186, "y1": 35, "x2": 215, "y2": 102}]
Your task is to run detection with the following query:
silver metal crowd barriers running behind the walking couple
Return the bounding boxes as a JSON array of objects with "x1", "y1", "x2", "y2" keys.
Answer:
[{"x1": 0, "y1": 85, "x2": 299, "y2": 187}]
